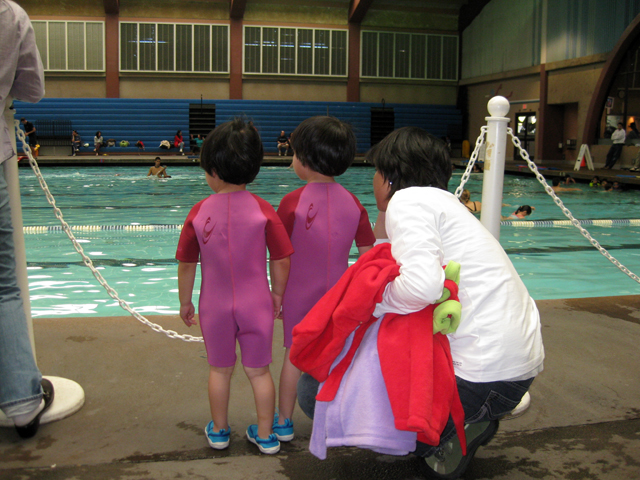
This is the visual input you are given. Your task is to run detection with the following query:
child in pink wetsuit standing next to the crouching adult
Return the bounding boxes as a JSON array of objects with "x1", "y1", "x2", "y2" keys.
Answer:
[{"x1": 273, "y1": 117, "x2": 375, "y2": 441}]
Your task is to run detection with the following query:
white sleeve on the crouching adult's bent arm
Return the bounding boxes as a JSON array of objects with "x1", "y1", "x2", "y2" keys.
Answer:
[{"x1": 374, "y1": 187, "x2": 444, "y2": 317}]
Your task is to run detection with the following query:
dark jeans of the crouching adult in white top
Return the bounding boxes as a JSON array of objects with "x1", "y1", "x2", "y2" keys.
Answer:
[{"x1": 298, "y1": 373, "x2": 533, "y2": 457}]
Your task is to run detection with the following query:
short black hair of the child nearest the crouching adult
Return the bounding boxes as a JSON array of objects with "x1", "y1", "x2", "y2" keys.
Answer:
[{"x1": 291, "y1": 116, "x2": 356, "y2": 177}]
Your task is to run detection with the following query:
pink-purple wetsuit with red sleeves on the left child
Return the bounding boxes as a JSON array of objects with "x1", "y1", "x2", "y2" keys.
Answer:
[{"x1": 176, "y1": 191, "x2": 293, "y2": 368}]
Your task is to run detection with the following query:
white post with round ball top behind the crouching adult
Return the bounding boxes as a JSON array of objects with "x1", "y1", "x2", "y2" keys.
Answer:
[{"x1": 480, "y1": 97, "x2": 509, "y2": 240}]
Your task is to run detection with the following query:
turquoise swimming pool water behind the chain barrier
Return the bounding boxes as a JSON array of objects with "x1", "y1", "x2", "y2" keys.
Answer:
[{"x1": 20, "y1": 165, "x2": 640, "y2": 317}]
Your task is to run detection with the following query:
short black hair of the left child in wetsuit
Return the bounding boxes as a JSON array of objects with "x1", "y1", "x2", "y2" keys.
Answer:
[{"x1": 200, "y1": 118, "x2": 264, "y2": 185}]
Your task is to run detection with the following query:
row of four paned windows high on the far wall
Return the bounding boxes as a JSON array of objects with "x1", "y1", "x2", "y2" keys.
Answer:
[{"x1": 32, "y1": 20, "x2": 458, "y2": 80}]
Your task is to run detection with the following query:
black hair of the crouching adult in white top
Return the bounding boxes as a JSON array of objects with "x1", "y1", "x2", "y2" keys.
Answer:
[{"x1": 366, "y1": 127, "x2": 452, "y2": 198}]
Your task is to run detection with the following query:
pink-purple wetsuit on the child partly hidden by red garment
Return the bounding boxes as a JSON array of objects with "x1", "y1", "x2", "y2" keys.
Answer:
[{"x1": 278, "y1": 183, "x2": 376, "y2": 347}]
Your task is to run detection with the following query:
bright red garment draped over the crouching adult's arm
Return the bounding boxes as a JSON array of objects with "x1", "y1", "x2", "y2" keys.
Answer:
[{"x1": 290, "y1": 243, "x2": 466, "y2": 453}]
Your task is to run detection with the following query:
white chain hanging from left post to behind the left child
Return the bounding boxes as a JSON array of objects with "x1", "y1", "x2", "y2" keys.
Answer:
[{"x1": 15, "y1": 120, "x2": 204, "y2": 342}]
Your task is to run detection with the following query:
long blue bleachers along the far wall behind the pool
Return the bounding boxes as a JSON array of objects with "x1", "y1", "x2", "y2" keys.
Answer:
[{"x1": 15, "y1": 98, "x2": 462, "y2": 154}]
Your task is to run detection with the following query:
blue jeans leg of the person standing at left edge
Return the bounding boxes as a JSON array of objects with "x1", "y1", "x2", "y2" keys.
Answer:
[{"x1": 0, "y1": 165, "x2": 42, "y2": 419}]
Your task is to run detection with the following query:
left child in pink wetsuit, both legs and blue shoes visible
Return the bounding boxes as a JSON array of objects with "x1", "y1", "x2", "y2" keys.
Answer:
[{"x1": 176, "y1": 119, "x2": 293, "y2": 454}]
